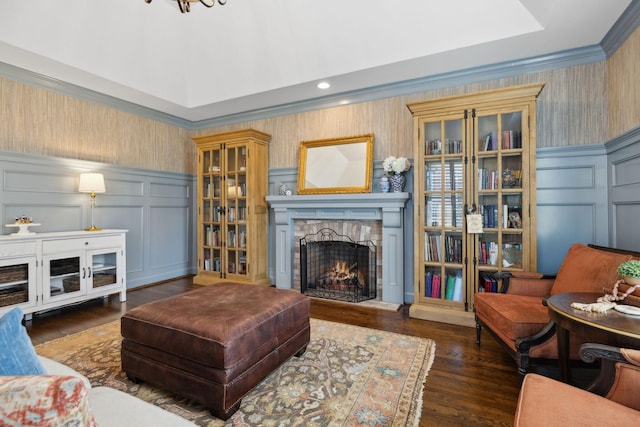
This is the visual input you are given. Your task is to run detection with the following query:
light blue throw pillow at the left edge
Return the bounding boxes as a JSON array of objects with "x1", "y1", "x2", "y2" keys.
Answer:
[{"x1": 0, "y1": 307, "x2": 47, "y2": 375}]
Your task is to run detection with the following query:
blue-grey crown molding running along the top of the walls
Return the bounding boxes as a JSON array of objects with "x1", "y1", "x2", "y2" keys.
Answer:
[{"x1": 0, "y1": 18, "x2": 640, "y2": 130}]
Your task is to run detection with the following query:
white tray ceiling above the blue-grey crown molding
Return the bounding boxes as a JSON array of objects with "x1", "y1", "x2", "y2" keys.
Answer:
[{"x1": 0, "y1": 0, "x2": 631, "y2": 121}]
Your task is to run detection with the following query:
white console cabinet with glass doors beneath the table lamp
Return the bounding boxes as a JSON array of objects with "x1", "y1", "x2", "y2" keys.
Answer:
[{"x1": 0, "y1": 230, "x2": 127, "y2": 318}]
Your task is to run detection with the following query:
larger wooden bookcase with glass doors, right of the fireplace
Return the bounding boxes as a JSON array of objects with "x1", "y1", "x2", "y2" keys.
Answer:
[{"x1": 408, "y1": 83, "x2": 543, "y2": 326}]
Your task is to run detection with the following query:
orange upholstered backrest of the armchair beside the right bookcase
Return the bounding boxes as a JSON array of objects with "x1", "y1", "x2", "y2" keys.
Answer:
[{"x1": 551, "y1": 243, "x2": 631, "y2": 295}]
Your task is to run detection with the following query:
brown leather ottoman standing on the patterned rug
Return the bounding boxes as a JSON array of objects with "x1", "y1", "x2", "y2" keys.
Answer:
[{"x1": 121, "y1": 283, "x2": 310, "y2": 420}]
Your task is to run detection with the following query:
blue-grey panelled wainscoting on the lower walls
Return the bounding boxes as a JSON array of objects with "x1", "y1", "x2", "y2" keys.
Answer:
[{"x1": 6, "y1": 133, "x2": 640, "y2": 303}]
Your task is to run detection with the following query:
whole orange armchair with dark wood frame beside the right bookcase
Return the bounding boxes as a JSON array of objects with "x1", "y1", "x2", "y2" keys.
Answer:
[{"x1": 474, "y1": 244, "x2": 639, "y2": 375}]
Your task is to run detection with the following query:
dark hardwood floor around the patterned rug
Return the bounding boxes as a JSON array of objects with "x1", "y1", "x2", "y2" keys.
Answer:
[{"x1": 27, "y1": 278, "x2": 520, "y2": 427}]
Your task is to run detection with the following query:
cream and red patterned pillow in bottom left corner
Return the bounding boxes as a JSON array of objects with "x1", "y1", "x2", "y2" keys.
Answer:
[{"x1": 0, "y1": 375, "x2": 96, "y2": 427}]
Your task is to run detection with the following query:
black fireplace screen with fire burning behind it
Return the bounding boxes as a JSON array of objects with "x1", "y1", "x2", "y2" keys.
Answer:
[{"x1": 300, "y1": 228, "x2": 377, "y2": 302}]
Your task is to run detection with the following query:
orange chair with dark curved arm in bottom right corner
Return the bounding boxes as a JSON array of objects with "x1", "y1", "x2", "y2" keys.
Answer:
[{"x1": 514, "y1": 344, "x2": 640, "y2": 427}]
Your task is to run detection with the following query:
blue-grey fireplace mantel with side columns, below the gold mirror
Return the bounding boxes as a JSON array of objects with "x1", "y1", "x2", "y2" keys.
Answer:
[{"x1": 267, "y1": 193, "x2": 410, "y2": 304}]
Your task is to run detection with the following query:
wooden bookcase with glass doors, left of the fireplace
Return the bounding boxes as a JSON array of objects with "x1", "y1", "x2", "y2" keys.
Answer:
[{"x1": 193, "y1": 129, "x2": 271, "y2": 286}]
